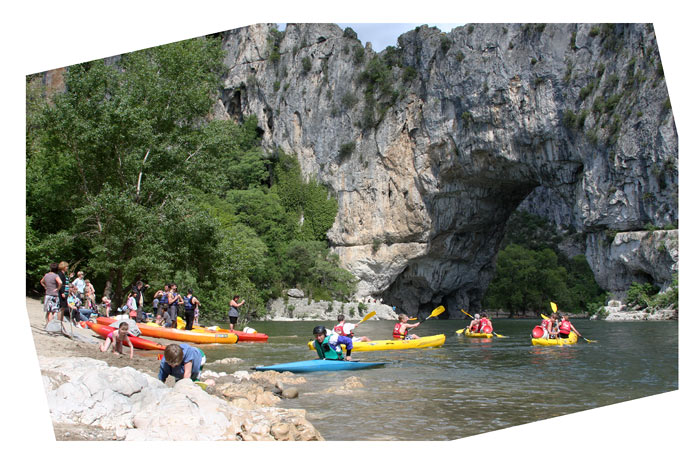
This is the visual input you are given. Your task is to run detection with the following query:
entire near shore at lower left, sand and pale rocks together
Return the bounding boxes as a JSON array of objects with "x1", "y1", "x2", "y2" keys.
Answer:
[{"x1": 26, "y1": 298, "x2": 323, "y2": 441}]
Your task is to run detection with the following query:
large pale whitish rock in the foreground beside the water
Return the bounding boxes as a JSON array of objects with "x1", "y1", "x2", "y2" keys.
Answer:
[{"x1": 39, "y1": 357, "x2": 323, "y2": 441}]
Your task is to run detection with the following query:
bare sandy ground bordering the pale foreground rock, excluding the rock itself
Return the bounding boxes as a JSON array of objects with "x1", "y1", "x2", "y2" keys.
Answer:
[{"x1": 26, "y1": 298, "x2": 174, "y2": 441}]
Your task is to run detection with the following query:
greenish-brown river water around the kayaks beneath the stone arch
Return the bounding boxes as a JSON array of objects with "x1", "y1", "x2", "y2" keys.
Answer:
[{"x1": 197, "y1": 319, "x2": 678, "y2": 441}]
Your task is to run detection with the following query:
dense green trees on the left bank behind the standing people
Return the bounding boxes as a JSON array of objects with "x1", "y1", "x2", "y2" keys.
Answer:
[{"x1": 26, "y1": 37, "x2": 354, "y2": 319}]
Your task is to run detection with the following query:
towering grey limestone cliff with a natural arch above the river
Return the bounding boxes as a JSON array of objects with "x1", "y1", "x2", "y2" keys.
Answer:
[{"x1": 216, "y1": 24, "x2": 678, "y2": 313}]
